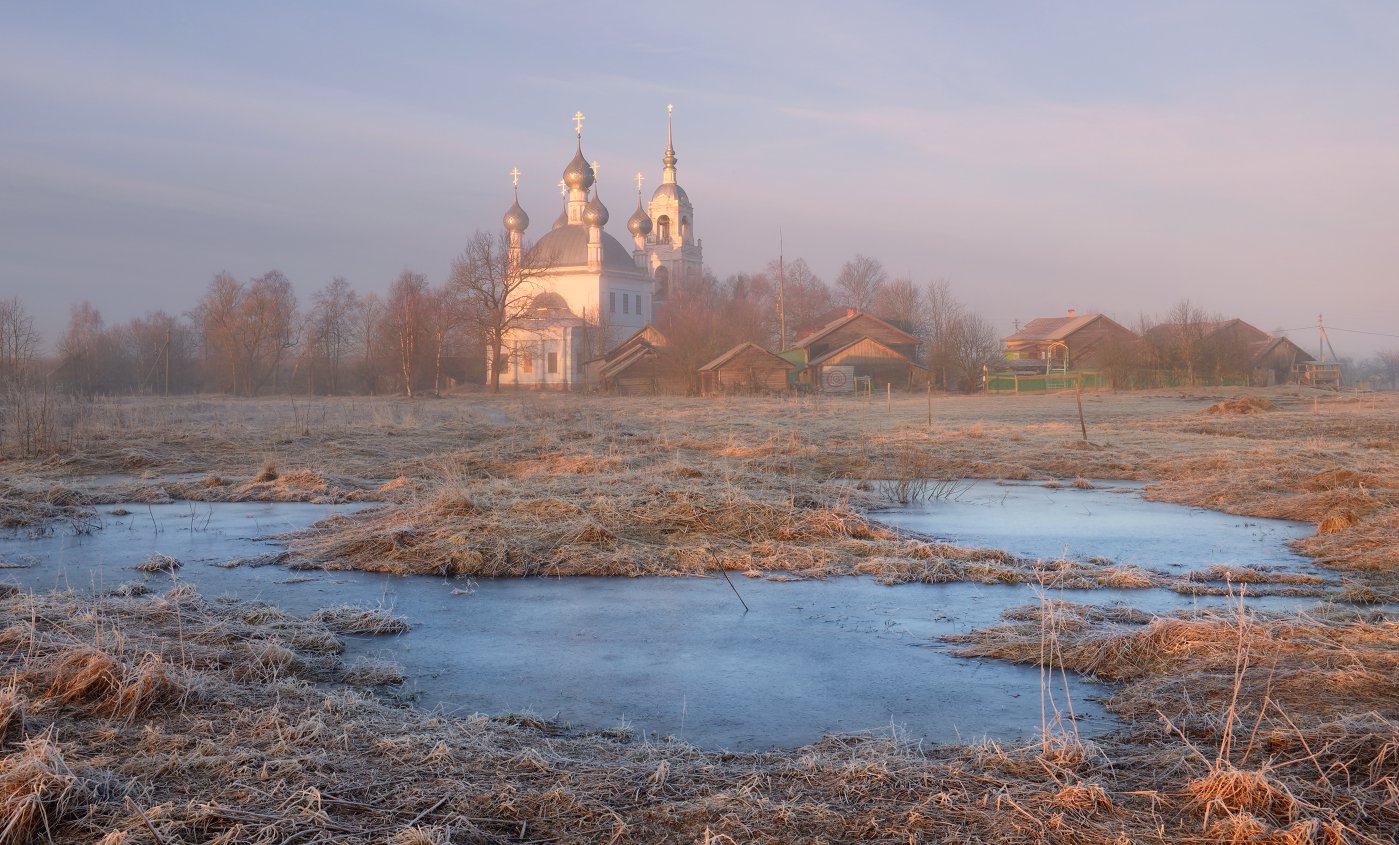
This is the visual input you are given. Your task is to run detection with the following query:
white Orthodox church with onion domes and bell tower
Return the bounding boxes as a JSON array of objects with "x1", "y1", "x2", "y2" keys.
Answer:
[{"x1": 501, "y1": 106, "x2": 704, "y2": 389}]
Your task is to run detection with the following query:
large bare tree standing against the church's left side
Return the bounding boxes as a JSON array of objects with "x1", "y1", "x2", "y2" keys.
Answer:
[{"x1": 450, "y1": 231, "x2": 554, "y2": 393}]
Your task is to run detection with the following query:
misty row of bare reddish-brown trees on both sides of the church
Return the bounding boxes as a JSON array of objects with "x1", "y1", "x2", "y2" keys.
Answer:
[{"x1": 0, "y1": 244, "x2": 1000, "y2": 396}]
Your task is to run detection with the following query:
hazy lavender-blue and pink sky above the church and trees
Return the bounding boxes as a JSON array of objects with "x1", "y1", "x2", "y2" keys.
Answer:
[{"x1": 0, "y1": 0, "x2": 1399, "y2": 357}]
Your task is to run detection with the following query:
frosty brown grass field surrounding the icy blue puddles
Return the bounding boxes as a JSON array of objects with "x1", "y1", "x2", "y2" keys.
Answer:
[{"x1": 0, "y1": 389, "x2": 1399, "y2": 844}]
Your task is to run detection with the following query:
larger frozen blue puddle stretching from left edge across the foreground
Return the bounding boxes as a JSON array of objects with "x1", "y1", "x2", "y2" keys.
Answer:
[{"x1": 0, "y1": 498, "x2": 1320, "y2": 750}]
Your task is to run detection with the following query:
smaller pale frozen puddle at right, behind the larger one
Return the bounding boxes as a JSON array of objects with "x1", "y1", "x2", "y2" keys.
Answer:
[{"x1": 876, "y1": 481, "x2": 1316, "y2": 572}]
